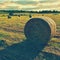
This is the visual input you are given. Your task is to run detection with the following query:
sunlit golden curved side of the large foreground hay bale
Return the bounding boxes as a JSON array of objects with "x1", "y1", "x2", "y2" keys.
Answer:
[{"x1": 40, "y1": 16, "x2": 56, "y2": 37}]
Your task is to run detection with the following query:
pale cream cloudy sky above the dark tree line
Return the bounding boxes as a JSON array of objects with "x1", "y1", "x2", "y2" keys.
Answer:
[{"x1": 0, "y1": 0, "x2": 60, "y2": 11}]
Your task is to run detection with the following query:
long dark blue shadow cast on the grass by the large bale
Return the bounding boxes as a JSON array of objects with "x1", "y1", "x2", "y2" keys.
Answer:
[{"x1": 0, "y1": 40, "x2": 60, "y2": 60}]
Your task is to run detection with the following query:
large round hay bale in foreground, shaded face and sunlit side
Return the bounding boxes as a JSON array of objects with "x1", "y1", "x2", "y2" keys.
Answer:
[{"x1": 24, "y1": 17, "x2": 56, "y2": 43}]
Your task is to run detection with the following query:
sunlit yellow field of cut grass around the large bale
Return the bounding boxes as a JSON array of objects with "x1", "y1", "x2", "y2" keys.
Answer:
[{"x1": 0, "y1": 13, "x2": 60, "y2": 54}]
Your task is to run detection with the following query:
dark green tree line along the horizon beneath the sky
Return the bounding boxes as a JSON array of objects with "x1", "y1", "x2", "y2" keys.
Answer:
[{"x1": 0, "y1": 10, "x2": 60, "y2": 14}]
